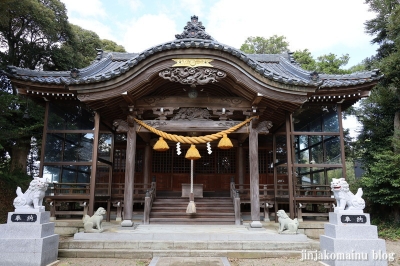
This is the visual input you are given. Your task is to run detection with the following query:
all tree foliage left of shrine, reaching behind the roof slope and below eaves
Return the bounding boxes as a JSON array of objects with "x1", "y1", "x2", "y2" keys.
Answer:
[{"x1": 0, "y1": 0, "x2": 124, "y2": 175}]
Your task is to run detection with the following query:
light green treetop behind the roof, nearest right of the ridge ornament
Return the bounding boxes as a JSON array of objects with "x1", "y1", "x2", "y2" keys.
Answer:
[{"x1": 240, "y1": 35, "x2": 289, "y2": 54}]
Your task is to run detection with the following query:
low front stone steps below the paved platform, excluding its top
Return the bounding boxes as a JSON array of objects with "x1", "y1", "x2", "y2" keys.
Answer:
[{"x1": 58, "y1": 240, "x2": 319, "y2": 259}]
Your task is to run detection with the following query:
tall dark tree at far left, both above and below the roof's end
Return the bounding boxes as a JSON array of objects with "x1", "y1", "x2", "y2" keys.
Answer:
[{"x1": 0, "y1": 0, "x2": 71, "y2": 172}]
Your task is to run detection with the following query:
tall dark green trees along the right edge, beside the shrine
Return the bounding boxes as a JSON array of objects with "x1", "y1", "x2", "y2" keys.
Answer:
[{"x1": 357, "y1": 0, "x2": 400, "y2": 221}]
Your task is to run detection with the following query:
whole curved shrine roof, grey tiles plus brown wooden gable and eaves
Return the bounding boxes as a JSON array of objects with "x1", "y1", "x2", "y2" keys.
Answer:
[{"x1": 8, "y1": 16, "x2": 381, "y2": 126}]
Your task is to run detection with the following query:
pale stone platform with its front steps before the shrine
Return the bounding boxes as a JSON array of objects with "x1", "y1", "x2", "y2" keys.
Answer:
[{"x1": 58, "y1": 224, "x2": 319, "y2": 259}]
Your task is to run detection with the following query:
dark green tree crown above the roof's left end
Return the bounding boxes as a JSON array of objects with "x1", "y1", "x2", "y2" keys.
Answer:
[{"x1": 0, "y1": 0, "x2": 71, "y2": 69}]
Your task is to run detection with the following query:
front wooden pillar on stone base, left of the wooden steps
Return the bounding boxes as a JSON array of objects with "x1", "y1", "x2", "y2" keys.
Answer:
[{"x1": 121, "y1": 115, "x2": 136, "y2": 227}]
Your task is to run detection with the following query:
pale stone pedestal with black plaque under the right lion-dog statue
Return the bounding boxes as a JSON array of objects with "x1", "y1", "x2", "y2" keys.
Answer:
[{"x1": 319, "y1": 211, "x2": 388, "y2": 266}]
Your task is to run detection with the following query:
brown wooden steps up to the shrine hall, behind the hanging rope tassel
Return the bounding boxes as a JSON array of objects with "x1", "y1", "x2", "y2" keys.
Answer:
[{"x1": 150, "y1": 197, "x2": 235, "y2": 225}]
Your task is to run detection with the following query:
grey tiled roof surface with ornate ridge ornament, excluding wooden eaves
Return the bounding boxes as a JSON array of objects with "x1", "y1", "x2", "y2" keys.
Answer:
[{"x1": 8, "y1": 16, "x2": 381, "y2": 88}]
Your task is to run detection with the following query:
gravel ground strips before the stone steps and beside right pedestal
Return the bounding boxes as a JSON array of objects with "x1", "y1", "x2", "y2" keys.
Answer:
[{"x1": 54, "y1": 241, "x2": 400, "y2": 266}]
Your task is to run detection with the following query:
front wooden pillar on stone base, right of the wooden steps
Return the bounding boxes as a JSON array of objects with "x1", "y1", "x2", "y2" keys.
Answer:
[{"x1": 249, "y1": 123, "x2": 262, "y2": 228}]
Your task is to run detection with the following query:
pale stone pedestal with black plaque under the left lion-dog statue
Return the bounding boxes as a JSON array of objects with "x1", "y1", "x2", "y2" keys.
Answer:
[{"x1": 0, "y1": 210, "x2": 59, "y2": 266}]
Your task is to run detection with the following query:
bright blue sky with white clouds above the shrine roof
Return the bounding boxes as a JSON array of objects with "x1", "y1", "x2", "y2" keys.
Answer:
[{"x1": 61, "y1": 0, "x2": 377, "y2": 137}]
